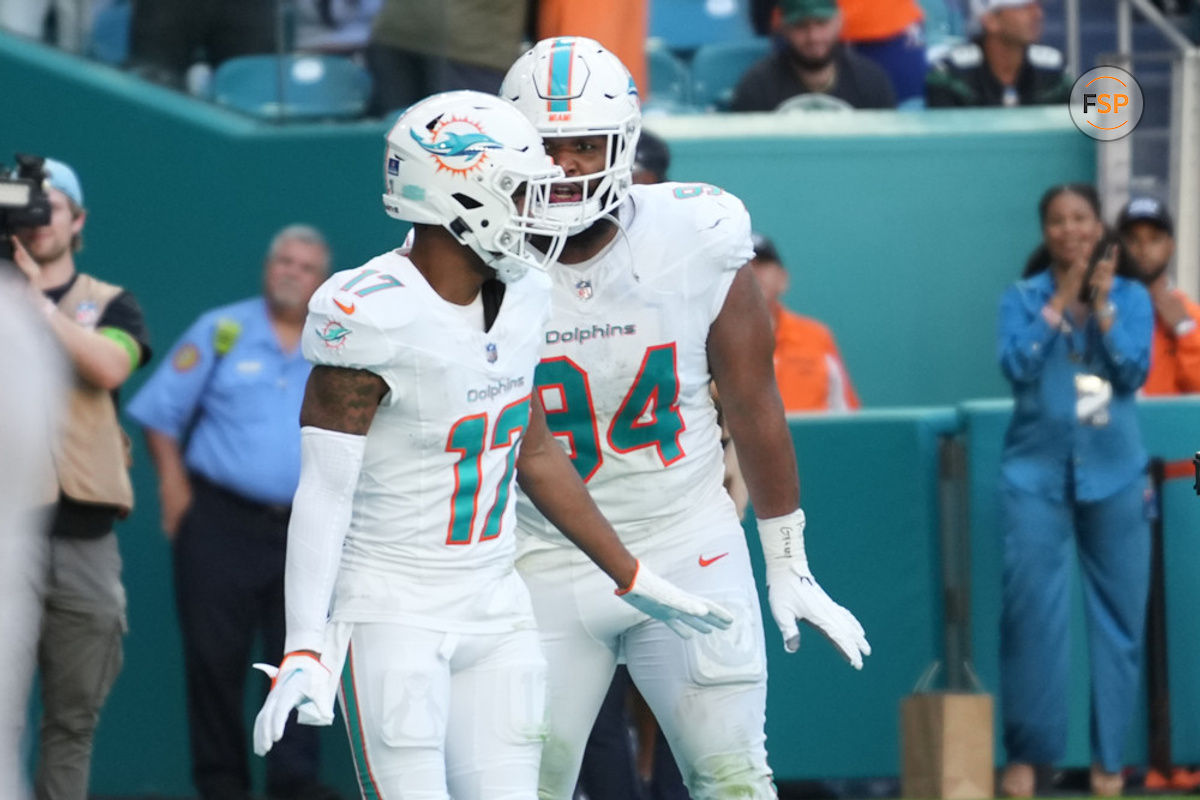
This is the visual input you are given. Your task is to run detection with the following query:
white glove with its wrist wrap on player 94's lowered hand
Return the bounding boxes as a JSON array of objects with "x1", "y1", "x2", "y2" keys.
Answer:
[{"x1": 758, "y1": 509, "x2": 871, "y2": 669}]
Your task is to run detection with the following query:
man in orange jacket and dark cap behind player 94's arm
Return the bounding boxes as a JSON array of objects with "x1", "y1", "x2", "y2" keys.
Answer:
[{"x1": 750, "y1": 233, "x2": 860, "y2": 411}]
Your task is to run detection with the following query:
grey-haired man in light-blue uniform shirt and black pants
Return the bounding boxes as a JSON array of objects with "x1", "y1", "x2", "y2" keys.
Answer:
[{"x1": 128, "y1": 225, "x2": 334, "y2": 800}]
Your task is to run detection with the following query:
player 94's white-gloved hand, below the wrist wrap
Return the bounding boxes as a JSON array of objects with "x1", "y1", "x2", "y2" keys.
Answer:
[{"x1": 767, "y1": 564, "x2": 871, "y2": 669}]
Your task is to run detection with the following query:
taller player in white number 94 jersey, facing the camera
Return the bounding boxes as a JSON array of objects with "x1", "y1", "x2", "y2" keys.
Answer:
[{"x1": 500, "y1": 37, "x2": 870, "y2": 800}]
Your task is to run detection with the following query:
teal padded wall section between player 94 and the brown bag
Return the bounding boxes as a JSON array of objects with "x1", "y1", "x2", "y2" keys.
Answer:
[{"x1": 746, "y1": 408, "x2": 958, "y2": 780}]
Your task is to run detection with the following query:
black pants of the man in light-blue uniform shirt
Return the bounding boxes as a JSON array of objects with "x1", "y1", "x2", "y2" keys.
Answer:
[{"x1": 174, "y1": 475, "x2": 317, "y2": 800}]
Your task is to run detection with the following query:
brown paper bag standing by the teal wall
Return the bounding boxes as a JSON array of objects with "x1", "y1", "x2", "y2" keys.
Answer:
[{"x1": 900, "y1": 692, "x2": 995, "y2": 800}]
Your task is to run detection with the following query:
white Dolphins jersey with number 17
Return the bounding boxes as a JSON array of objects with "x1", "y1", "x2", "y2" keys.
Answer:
[{"x1": 302, "y1": 251, "x2": 550, "y2": 632}]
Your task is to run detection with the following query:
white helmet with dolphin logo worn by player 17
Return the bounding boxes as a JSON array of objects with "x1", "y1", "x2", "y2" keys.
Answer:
[{"x1": 383, "y1": 91, "x2": 566, "y2": 283}]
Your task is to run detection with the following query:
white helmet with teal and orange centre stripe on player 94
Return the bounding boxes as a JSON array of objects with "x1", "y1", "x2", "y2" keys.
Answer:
[{"x1": 500, "y1": 36, "x2": 642, "y2": 234}]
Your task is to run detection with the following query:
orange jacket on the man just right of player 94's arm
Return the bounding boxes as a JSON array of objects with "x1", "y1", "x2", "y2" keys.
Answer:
[{"x1": 774, "y1": 308, "x2": 860, "y2": 411}]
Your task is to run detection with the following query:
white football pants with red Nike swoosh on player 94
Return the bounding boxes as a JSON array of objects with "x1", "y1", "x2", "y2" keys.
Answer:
[{"x1": 517, "y1": 512, "x2": 775, "y2": 800}]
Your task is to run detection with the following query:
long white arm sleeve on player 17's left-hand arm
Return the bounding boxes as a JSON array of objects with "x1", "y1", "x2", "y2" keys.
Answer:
[{"x1": 283, "y1": 426, "x2": 367, "y2": 652}]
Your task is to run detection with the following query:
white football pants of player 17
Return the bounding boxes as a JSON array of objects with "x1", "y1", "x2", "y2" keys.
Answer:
[{"x1": 338, "y1": 622, "x2": 546, "y2": 800}]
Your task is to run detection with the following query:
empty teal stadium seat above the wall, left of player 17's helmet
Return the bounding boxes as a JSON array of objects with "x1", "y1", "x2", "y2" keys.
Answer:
[{"x1": 212, "y1": 55, "x2": 371, "y2": 120}]
